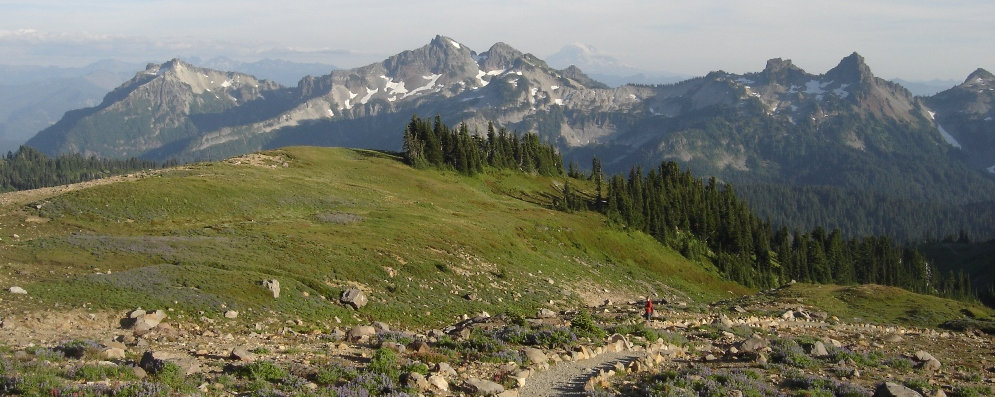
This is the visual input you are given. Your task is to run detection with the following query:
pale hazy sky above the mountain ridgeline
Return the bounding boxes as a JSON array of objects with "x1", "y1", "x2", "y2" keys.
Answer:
[{"x1": 0, "y1": 0, "x2": 995, "y2": 80}]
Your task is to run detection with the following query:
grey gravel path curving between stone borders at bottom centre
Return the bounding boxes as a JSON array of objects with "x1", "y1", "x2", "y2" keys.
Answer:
[{"x1": 518, "y1": 351, "x2": 645, "y2": 397}]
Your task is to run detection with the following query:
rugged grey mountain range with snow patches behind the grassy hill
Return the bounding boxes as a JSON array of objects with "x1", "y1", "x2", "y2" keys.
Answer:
[{"x1": 19, "y1": 36, "x2": 995, "y2": 238}]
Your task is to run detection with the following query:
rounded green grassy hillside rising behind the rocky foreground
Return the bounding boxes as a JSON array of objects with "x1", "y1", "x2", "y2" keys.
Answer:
[{"x1": 0, "y1": 147, "x2": 748, "y2": 325}]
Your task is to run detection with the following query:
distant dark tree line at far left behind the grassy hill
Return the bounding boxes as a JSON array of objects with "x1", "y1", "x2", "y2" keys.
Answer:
[{"x1": 0, "y1": 146, "x2": 169, "y2": 192}]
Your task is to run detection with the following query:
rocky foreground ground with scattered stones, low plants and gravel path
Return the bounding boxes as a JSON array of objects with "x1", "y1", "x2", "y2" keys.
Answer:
[{"x1": 0, "y1": 291, "x2": 995, "y2": 396}]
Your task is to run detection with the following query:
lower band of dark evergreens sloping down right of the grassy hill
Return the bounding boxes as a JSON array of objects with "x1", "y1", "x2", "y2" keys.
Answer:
[{"x1": 584, "y1": 159, "x2": 974, "y2": 298}]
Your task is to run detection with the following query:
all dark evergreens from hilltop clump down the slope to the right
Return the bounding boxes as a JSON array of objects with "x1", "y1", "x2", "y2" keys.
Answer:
[{"x1": 403, "y1": 116, "x2": 987, "y2": 306}]
